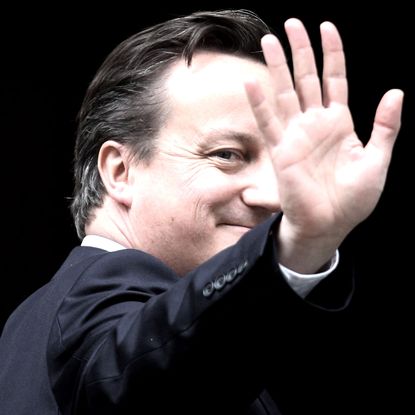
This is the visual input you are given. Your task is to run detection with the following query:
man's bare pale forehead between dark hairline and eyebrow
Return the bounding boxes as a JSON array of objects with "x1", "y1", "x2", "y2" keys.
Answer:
[{"x1": 165, "y1": 52, "x2": 272, "y2": 140}]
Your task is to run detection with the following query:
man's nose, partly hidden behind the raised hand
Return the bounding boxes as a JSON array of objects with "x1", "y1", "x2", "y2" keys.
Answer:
[{"x1": 242, "y1": 158, "x2": 281, "y2": 213}]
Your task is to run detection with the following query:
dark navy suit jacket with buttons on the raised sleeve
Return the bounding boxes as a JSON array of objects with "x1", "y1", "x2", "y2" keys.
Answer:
[{"x1": 0, "y1": 216, "x2": 349, "y2": 415}]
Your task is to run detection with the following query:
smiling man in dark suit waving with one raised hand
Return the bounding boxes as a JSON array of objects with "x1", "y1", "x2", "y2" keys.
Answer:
[{"x1": 0, "y1": 11, "x2": 403, "y2": 415}]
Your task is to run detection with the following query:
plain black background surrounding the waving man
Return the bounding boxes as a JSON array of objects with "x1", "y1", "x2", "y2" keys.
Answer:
[{"x1": 0, "y1": 1, "x2": 415, "y2": 414}]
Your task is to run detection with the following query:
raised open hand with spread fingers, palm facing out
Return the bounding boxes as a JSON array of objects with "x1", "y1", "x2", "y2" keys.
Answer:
[{"x1": 246, "y1": 19, "x2": 403, "y2": 272}]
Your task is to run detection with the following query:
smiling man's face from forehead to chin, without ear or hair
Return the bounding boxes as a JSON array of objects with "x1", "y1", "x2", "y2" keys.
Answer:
[{"x1": 129, "y1": 53, "x2": 279, "y2": 275}]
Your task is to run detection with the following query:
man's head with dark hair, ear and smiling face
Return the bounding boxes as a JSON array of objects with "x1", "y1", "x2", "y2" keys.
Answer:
[{"x1": 72, "y1": 11, "x2": 279, "y2": 273}]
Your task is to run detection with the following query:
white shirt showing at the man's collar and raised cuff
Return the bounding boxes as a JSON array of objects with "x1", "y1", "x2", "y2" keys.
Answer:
[{"x1": 81, "y1": 235, "x2": 339, "y2": 298}]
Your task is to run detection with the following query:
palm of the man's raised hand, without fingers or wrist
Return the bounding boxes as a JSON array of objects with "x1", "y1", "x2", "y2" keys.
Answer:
[{"x1": 271, "y1": 105, "x2": 374, "y2": 237}]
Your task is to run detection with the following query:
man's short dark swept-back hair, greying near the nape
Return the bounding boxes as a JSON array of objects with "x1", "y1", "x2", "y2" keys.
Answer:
[{"x1": 71, "y1": 10, "x2": 271, "y2": 238}]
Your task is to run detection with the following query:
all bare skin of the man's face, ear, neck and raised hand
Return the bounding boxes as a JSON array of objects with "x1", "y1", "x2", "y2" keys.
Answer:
[{"x1": 86, "y1": 19, "x2": 403, "y2": 275}]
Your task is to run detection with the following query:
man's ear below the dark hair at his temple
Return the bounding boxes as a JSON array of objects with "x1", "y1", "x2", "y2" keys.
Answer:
[{"x1": 98, "y1": 140, "x2": 132, "y2": 207}]
